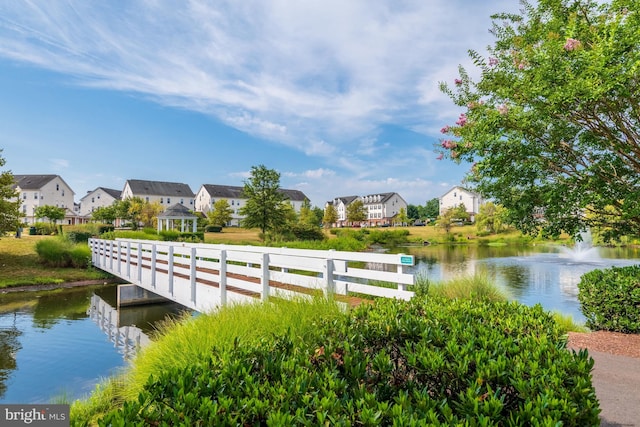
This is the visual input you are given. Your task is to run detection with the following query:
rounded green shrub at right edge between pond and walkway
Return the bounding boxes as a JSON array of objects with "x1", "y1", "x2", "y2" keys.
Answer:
[{"x1": 578, "y1": 265, "x2": 640, "y2": 334}]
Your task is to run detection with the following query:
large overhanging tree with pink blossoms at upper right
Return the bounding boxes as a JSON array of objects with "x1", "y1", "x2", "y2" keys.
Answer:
[{"x1": 439, "y1": 0, "x2": 640, "y2": 241}]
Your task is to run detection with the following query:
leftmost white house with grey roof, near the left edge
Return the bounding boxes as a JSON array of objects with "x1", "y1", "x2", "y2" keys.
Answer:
[{"x1": 13, "y1": 175, "x2": 78, "y2": 225}]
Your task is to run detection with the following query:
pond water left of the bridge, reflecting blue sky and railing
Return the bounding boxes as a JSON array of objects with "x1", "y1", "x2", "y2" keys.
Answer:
[{"x1": 0, "y1": 285, "x2": 189, "y2": 404}]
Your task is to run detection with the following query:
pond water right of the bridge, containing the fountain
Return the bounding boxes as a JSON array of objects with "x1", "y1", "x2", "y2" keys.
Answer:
[{"x1": 392, "y1": 245, "x2": 640, "y2": 322}]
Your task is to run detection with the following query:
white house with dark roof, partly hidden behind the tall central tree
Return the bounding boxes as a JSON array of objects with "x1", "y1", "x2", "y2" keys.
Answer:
[{"x1": 195, "y1": 184, "x2": 307, "y2": 226}]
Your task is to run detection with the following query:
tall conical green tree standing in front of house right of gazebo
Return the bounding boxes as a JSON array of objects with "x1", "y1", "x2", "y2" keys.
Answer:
[{"x1": 239, "y1": 165, "x2": 286, "y2": 239}]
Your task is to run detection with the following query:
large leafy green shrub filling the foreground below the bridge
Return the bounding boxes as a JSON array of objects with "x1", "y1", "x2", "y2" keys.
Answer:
[{"x1": 99, "y1": 298, "x2": 599, "y2": 426}]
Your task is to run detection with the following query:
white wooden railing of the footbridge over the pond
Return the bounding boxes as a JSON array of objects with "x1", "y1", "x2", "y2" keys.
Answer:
[{"x1": 89, "y1": 239, "x2": 414, "y2": 312}]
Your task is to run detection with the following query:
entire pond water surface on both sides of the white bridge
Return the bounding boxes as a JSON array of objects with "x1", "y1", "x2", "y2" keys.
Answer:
[{"x1": 0, "y1": 245, "x2": 640, "y2": 404}]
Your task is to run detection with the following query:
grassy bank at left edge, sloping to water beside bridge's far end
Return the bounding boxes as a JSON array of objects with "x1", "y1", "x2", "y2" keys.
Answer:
[{"x1": 0, "y1": 235, "x2": 110, "y2": 289}]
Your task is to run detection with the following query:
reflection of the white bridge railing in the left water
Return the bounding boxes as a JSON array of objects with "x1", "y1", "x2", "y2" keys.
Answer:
[{"x1": 87, "y1": 294, "x2": 151, "y2": 359}]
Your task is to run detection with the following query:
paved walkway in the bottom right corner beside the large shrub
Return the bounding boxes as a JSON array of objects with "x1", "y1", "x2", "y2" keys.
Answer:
[{"x1": 589, "y1": 350, "x2": 640, "y2": 427}]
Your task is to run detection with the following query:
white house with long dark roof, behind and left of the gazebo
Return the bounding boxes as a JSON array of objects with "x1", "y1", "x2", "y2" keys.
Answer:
[{"x1": 120, "y1": 179, "x2": 195, "y2": 211}]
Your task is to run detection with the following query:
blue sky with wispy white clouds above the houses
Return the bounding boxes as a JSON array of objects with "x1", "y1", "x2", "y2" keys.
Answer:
[{"x1": 0, "y1": 0, "x2": 519, "y2": 207}]
